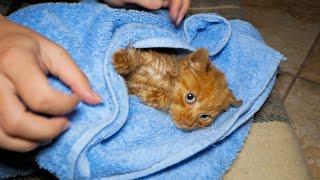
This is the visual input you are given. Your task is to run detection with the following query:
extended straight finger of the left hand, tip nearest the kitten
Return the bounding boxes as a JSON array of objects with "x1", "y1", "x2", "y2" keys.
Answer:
[{"x1": 45, "y1": 44, "x2": 102, "y2": 104}]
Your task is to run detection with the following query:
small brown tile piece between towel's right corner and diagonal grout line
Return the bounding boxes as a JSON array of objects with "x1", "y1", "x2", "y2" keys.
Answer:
[{"x1": 273, "y1": 71, "x2": 294, "y2": 101}]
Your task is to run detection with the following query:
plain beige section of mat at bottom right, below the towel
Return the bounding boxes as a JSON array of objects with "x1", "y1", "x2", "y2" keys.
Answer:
[{"x1": 224, "y1": 121, "x2": 311, "y2": 180}]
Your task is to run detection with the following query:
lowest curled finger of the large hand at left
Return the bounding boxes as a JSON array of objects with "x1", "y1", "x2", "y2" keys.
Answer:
[{"x1": 0, "y1": 74, "x2": 68, "y2": 152}]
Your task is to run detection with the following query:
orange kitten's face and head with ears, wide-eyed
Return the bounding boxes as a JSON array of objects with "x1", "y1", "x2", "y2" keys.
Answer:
[{"x1": 169, "y1": 49, "x2": 241, "y2": 130}]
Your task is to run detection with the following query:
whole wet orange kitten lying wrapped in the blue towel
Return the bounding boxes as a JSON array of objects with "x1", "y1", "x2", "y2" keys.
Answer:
[{"x1": 113, "y1": 49, "x2": 241, "y2": 130}]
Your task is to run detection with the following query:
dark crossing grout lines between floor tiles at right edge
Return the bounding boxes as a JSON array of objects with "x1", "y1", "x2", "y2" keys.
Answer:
[{"x1": 283, "y1": 32, "x2": 320, "y2": 103}]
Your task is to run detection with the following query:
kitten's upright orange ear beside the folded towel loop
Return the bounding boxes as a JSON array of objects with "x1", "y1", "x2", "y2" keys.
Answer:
[{"x1": 188, "y1": 48, "x2": 209, "y2": 72}]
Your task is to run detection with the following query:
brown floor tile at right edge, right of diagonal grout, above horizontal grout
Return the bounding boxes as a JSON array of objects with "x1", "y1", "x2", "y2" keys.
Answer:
[{"x1": 300, "y1": 35, "x2": 320, "y2": 83}]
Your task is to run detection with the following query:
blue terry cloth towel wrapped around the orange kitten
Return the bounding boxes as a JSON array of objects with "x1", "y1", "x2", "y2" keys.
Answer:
[{"x1": 0, "y1": 3, "x2": 284, "y2": 179}]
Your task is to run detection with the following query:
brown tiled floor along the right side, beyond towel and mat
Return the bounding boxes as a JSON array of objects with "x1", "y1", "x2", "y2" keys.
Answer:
[{"x1": 243, "y1": 1, "x2": 320, "y2": 179}]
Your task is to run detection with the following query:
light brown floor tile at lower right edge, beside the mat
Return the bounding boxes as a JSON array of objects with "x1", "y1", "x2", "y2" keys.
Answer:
[{"x1": 285, "y1": 78, "x2": 320, "y2": 179}]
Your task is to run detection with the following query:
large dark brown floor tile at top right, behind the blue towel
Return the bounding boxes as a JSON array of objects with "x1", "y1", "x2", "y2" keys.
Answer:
[{"x1": 245, "y1": 6, "x2": 320, "y2": 74}]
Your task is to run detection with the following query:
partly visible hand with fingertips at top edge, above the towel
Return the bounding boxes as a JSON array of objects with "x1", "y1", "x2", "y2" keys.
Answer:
[{"x1": 104, "y1": 0, "x2": 190, "y2": 26}]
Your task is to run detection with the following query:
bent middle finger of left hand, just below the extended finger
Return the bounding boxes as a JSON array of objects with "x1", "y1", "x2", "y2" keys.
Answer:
[{"x1": 0, "y1": 48, "x2": 79, "y2": 115}]
